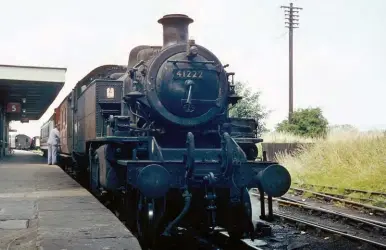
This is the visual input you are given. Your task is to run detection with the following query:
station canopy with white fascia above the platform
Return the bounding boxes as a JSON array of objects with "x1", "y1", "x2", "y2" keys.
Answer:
[{"x1": 0, "y1": 65, "x2": 67, "y2": 122}]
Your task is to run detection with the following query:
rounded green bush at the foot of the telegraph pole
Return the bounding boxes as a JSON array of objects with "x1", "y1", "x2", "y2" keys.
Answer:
[{"x1": 276, "y1": 108, "x2": 328, "y2": 138}]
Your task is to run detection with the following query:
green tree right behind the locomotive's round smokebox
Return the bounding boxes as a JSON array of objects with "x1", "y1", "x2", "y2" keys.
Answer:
[{"x1": 229, "y1": 82, "x2": 269, "y2": 135}]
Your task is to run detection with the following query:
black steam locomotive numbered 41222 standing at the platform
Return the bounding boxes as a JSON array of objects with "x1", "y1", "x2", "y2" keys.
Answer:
[{"x1": 42, "y1": 14, "x2": 291, "y2": 248}]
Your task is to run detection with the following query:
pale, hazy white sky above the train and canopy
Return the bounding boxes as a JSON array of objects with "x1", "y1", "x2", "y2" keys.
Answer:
[{"x1": 0, "y1": 0, "x2": 386, "y2": 136}]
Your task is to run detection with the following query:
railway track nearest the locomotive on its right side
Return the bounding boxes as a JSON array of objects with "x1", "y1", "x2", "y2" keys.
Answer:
[{"x1": 251, "y1": 192, "x2": 386, "y2": 249}]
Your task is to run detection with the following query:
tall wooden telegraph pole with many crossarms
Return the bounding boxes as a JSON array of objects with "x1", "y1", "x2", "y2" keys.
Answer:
[{"x1": 281, "y1": 3, "x2": 303, "y2": 122}]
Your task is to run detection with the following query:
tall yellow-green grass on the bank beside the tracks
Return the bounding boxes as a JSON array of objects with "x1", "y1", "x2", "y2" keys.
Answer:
[{"x1": 266, "y1": 130, "x2": 386, "y2": 192}]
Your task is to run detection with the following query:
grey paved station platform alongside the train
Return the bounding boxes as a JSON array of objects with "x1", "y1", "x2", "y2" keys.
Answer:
[{"x1": 0, "y1": 150, "x2": 141, "y2": 250}]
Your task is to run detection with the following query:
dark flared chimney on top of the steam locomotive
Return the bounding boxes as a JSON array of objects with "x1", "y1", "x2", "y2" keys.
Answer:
[{"x1": 158, "y1": 14, "x2": 193, "y2": 48}]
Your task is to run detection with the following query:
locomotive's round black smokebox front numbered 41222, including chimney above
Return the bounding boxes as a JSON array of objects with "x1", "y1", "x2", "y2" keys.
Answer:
[{"x1": 146, "y1": 14, "x2": 228, "y2": 126}]
